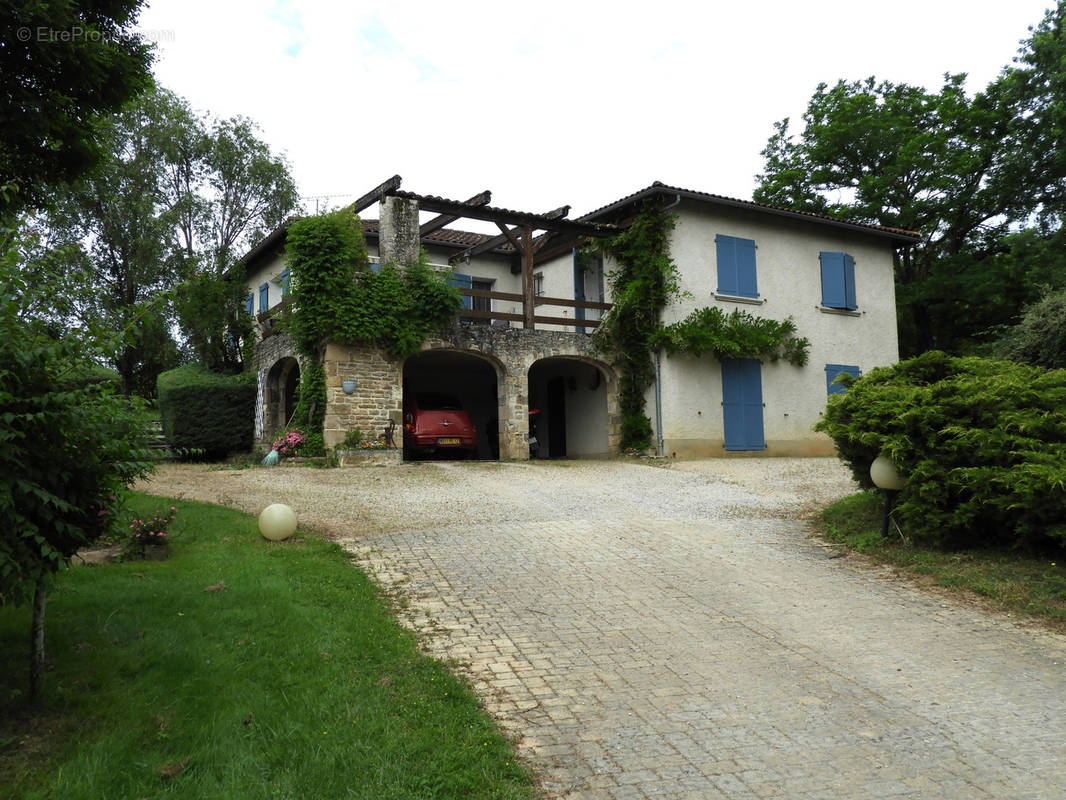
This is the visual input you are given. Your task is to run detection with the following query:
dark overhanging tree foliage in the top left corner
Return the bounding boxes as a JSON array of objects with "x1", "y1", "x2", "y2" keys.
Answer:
[{"x1": 0, "y1": 0, "x2": 151, "y2": 218}]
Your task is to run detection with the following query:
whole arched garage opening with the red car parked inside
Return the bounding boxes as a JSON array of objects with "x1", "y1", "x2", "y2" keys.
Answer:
[{"x1": 403, "y1": 350, "x2": 500, "y2": 461}]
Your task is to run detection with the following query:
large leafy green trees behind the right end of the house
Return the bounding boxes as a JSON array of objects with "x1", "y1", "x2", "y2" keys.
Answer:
[{"x1": 755, "y1": 2, "x2": 1066, "y2": 353}]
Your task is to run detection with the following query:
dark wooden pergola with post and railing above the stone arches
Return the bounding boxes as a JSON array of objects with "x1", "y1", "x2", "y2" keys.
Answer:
[{"x1": 350, "y1": 175, "x2": 623, "y2": 330}]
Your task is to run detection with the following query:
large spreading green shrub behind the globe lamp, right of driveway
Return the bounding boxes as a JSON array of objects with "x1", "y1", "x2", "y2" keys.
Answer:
[{"x1": 815, "y1": 351, "x2": 1066, "y2": 547}]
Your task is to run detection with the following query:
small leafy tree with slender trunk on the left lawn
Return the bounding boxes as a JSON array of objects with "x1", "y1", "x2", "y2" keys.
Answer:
[{"x1": 0, "y1": 220, "x2": 151, "y2": 697}]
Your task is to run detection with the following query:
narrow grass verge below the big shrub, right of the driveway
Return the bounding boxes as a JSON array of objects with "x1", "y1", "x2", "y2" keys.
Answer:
[{"x1": 822, "y1": 492, "x2": 1066, "y2": 633}]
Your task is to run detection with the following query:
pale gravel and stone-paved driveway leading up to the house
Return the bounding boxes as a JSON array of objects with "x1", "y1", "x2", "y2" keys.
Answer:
[{"x1": 148, "y1": 459, "x2": 1066, "y2": 800}]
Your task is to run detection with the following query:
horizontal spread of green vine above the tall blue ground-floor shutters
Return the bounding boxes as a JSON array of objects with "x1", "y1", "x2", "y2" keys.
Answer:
[{"x1": 649, "y1": 306, "x2": 810, "y2": 367}]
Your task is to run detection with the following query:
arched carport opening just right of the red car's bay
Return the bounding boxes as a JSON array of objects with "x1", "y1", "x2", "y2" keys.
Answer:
[{"x1": 529, "y1": 357, "x2": 610, "y2": 459}]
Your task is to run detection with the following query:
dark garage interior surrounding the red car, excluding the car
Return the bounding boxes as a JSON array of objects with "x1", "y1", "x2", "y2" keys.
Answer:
[{"x1": 403, "y1": 350, "x2": 500, "y2": 461}]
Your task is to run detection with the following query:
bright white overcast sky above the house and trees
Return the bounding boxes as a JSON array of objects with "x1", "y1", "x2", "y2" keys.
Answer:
[{"x1": 139, "y1": 0, "x2": 1051, "y2": 222}]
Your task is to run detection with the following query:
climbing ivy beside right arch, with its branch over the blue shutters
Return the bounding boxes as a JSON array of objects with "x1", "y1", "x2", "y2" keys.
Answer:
[{"x1": 594, "y1": 204, "x2": 810, "y2": 451}]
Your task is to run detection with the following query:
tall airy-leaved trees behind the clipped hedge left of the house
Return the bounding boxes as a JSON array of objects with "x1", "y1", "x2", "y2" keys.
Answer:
[{"x1": 47, "y1": 89, "x2": 297, "y2": 388}]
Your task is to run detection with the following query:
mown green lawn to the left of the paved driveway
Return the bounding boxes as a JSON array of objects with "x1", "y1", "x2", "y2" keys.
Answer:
[{"x1": 0, "y1": 495, "x2": 536, "y2": 800}]
